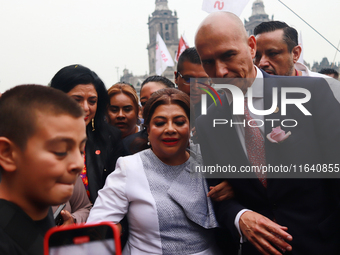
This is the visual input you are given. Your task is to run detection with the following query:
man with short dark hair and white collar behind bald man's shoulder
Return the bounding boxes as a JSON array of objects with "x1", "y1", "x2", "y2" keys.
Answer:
[{"x1": 254, "y1": 21, "x2": 340, "y2": 102}]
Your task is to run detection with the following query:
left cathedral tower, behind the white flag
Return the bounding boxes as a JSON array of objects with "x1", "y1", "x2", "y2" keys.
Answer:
[{"x1": 147, "y1": 0, "x2": 179, "y2": 80}]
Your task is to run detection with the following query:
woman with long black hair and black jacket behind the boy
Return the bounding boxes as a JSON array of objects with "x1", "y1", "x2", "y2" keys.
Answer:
[{"x1": 51, "y1": 65, "x2": 125, "y2": 203}]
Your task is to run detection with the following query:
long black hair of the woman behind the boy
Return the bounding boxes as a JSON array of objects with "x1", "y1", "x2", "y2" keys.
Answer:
[{"x1": 50, "y1": 65, "x2": 109, "y2": 139}]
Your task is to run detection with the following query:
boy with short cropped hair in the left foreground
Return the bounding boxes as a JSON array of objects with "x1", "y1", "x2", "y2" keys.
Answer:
[{"x1": 0, "y1": 85, "x2": 86, "y2": 255}]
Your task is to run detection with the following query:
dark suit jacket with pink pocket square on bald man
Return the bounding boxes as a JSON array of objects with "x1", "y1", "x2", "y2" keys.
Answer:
[{"x1": 196, "y1": 69, "x2": 340, "y2": 254}]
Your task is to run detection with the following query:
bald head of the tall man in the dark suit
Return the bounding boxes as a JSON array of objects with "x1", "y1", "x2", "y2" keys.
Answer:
[{"x1": 195, "y1": 12, "x2": 256, "y2": 81}]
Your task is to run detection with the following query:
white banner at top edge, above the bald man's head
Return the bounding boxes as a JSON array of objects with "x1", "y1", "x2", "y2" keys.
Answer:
[{"x1": 202, "y1": 0, "x2": 249, "y2": 17}]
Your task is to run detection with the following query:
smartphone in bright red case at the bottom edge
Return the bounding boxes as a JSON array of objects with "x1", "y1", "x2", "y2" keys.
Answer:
[{"x1": 44, "y1": 222, "x2": 121, "y2": 255}]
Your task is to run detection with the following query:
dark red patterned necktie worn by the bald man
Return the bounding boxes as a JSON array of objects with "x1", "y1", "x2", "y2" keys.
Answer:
[{"x1": 244, "y1": 97, "x2": 267, "y2": 187}]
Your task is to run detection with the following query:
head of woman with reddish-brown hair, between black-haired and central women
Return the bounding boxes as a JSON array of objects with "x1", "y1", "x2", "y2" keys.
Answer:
[{"x1": 108, "y1": 83, "x2": 139, "y2": 138}]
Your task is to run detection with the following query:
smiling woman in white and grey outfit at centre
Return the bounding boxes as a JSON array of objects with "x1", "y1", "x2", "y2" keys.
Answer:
[{"x1": 88, "y1": 88, "x2": 218, "y2": 255}]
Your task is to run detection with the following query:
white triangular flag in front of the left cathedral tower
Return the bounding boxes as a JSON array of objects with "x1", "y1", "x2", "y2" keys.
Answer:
[{"x1": 156, "y1": 32, "x2": 175, "y2": 75}]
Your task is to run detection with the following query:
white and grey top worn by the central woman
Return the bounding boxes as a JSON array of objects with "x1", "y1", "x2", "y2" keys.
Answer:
[{"x1": 87, "y1": 149, "x2": 217, "y2": 255}]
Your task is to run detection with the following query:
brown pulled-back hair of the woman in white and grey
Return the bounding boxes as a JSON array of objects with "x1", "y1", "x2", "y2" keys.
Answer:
[{"x1": 143, "y1": 88, "x2": 195, "y2": 127}]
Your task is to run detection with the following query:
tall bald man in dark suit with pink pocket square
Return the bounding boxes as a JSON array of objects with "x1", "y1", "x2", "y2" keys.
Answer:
[{"x1": 195, "y1": 12, "x2": 340, "y2": 254}]
